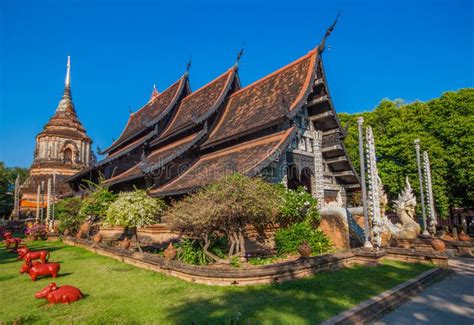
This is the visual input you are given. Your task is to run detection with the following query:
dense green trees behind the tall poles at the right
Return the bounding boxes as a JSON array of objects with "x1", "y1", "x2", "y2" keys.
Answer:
[{"x1": 339, "y1": 88, "x2": 474, "y2": 216}]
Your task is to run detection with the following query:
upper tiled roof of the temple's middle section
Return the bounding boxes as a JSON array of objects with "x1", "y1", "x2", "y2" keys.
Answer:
[{"x1": 158, "y1": 67, "x2": 236, "y2": 142}]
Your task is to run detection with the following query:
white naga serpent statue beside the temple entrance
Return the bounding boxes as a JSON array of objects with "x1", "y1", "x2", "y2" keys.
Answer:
[{"x1": 392, "y1": 177, "x2": 421, "y2": 239}]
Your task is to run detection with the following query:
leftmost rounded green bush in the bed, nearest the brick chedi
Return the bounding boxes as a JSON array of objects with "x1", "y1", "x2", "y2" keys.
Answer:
[{"x1": 54, "y1": 197, "x2": 86, "y2": 233}]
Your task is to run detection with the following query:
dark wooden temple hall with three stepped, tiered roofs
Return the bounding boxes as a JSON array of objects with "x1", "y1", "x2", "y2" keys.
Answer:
[{"x1": 68, "y1": 20, "x2": 359, "y2": 204}]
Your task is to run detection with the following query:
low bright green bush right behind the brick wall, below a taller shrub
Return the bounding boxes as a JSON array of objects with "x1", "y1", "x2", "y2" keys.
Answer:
[{"x1": 275, "y1": 221, "x2": 331, "y2": 255}]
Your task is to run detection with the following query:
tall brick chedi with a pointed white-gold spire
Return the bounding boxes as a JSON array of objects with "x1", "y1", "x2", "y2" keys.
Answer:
[{"x1": 19, "y1": 57, "x2": 95, "y2": 216}]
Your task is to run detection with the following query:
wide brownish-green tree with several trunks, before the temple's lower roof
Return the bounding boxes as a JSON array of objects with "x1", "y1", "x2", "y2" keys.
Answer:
[{"x1": 165, "y1": 174, "x2": 281, "y2": 263}]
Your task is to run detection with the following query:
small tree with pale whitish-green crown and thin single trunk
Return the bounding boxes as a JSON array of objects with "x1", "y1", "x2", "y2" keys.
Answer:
[{"x1": 105, "y1": 190, "x2": 166, "y2": 252}]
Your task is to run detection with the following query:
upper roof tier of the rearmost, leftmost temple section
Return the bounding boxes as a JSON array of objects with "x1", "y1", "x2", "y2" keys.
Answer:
[{"x1": 104, "y1": 76, "x2": 187, "y2": 152}]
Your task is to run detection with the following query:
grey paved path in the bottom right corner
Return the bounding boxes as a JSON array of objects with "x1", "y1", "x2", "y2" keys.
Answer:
[{"x1": 373, "y1": 258, "x2": 474, "y2": 325}]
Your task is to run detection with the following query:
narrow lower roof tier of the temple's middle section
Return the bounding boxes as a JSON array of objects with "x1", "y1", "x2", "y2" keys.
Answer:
[{"x1": 104, "y1": 131, "x2": 204, "y2": 185}]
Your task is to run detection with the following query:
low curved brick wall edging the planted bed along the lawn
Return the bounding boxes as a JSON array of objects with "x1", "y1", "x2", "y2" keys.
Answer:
[{"x1": 63, "y1": 237, "x2": 447, "y2": 286}]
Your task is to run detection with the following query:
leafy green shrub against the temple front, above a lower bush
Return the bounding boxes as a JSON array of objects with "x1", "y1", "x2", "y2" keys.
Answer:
[{"x1": 277, "y1": 185, "x2": 321, "y2": 227}]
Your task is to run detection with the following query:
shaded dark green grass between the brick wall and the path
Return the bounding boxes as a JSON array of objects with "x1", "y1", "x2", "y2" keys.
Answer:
[{"x1": 162, "y1": 265, "x2": 427, "y2": 324}]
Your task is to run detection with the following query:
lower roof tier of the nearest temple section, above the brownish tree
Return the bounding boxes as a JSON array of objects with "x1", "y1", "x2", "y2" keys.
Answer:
[{"x1": 150, "y1": 128, "x2": 294, "y2": 196}]
